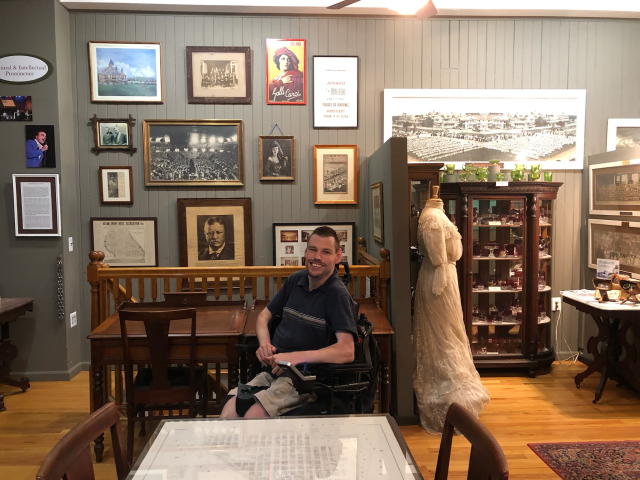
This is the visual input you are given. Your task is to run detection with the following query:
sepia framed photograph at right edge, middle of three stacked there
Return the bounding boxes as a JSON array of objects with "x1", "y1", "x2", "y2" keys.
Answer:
[{"x1": 589, "y1": 159, "x2": 640, "y2": 217}]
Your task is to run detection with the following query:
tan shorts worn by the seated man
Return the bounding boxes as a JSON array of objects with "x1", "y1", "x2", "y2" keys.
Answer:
[{"x1": 229, "y1": 372, "x2": 316, "y2": 417}]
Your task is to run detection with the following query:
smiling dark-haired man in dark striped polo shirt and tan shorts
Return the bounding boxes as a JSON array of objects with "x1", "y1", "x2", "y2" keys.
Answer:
[{"x1": 220, "y1": 227, "x2": 358, "y2": 418}]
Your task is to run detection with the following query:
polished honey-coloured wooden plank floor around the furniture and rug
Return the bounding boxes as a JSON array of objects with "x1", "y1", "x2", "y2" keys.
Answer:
[{"x1": 0, "y1": 364, "x2": 640, "y2": 480}]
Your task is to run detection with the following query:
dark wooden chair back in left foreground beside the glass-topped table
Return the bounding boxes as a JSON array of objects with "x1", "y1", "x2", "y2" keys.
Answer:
[{"x1": 36, "y1": 403, "x2": 131, "y2": 480}]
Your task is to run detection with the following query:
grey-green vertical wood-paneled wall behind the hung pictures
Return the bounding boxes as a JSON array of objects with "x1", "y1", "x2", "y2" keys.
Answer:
[{"x1": 71, "y1": 12, "x2": 640, "y2": 364}]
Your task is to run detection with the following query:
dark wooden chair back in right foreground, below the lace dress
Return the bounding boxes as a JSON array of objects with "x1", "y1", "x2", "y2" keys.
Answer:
[{"x1": 434, "y1": 403, "x2": 509, "y2": 480}]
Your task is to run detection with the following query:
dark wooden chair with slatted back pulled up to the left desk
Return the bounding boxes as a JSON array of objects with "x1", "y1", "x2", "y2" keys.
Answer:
[{"x1": 118, "y1": 303, "x2": 207, "y2": 462}]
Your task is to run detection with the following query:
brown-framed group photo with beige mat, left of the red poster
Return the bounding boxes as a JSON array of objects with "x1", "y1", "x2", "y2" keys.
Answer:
[{"x1": 187, "y1": 47, "x2": 251, "y2": 105}]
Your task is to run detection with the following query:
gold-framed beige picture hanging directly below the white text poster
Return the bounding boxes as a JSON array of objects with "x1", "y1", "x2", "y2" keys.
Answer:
[{"x1": 313, "y1": 145, "x2": 358, "y2": 205}]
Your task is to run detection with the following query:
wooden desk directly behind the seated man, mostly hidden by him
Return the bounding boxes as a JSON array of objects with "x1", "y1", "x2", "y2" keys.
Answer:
[{"x1": 240, "y1": 298, "x2": 395, "y2": 413}]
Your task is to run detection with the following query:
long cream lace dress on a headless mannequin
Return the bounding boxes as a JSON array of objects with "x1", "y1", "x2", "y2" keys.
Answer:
[{"x1": 413, "y1": 200, "x2": 489, "y2": 434}]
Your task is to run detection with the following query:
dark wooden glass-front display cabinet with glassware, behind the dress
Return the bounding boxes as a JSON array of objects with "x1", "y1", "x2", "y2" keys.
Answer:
[{"x1": 440, "y1": 182, "x2": 562, "y2": 376}]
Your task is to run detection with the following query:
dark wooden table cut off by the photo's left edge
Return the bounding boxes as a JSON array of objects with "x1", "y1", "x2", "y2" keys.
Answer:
[{"x1": 0, "y1": 298, "x2": 33, "y2": 412}]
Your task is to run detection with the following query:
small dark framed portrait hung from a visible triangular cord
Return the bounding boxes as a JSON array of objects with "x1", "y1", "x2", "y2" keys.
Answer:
[{"x1": 258, "y1": 135, "x2": 296, "y2": 181}]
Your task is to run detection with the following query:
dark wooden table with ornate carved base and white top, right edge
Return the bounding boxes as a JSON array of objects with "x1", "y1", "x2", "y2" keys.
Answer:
[{"x1": 562, "y1": 291, "x2": 640, "y2": 403}]
